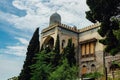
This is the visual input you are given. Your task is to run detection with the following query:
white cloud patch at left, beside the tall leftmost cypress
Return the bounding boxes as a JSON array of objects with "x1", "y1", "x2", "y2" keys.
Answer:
[{"x1": 0, "y1": 37, "x2": 29, "y2": 57}]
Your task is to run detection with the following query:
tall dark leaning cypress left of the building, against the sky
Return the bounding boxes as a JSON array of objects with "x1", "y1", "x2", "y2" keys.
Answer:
[{"x1": 18, "y1": 28, "x2": 40, "y2": 80}]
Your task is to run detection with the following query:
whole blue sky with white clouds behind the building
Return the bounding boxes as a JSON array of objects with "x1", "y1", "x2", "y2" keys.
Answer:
[{"x1": 0, "y1": 0, "x2": 92, "y2": 80}]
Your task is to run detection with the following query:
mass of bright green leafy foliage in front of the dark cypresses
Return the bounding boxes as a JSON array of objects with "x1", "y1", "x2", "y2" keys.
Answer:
[{"x1": 31, "y1": 50, "x2": 78, "y2": 80}]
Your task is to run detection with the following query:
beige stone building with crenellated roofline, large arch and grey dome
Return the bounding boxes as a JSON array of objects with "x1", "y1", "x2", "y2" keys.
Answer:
[{"x1": 41, "y1": 13, "x2": 119, "y2": 74}]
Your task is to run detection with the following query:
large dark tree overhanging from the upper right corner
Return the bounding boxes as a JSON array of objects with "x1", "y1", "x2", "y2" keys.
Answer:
[{"x1": 86, "y1": 0, "x2": 120, "y2": 55}]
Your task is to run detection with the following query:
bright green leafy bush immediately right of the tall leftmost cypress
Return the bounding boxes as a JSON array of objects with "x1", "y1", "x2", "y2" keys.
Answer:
[{"x1": 30, "y1": 50, "x2": 52, "y2": 80}]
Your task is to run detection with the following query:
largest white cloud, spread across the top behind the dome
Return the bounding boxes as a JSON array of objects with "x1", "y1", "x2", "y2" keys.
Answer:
[{"x1": 1, "y1": 0, "x2": 91, "y2": 31}]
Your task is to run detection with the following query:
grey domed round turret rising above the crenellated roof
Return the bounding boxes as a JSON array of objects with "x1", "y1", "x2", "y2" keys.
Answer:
[{"x1": 49, "y1": 12, "x2": 61, "y2": 25}]
